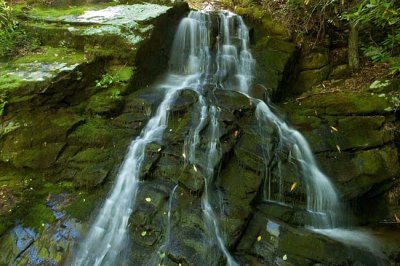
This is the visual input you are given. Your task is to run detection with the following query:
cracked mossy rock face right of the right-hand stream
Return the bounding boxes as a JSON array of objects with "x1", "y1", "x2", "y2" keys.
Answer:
[{"x1": 282, "y1": 92, "x2": 400, "y2": 223}]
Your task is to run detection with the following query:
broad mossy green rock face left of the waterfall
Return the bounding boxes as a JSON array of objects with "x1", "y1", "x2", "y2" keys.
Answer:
[{"x1": 0, "y1": 3, "x2": 188, "y2": 265}]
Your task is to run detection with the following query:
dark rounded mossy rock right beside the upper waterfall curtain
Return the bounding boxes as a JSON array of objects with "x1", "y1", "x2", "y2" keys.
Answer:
[{"x1": 231, "y1": 6, "x2": 298, "y2": 100}]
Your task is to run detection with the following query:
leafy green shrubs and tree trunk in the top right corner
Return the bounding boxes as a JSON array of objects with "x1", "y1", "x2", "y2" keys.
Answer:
[{"x1": 234, "y1": 0, "x2": 400, "y2": 74}]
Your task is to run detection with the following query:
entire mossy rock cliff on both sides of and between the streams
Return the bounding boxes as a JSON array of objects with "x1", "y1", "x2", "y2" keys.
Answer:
[{"x1": 0, "y1": 1, "x2": 400, "y2": 265}]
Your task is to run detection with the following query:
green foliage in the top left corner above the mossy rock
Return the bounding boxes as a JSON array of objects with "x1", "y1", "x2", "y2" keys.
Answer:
[{"x1": 0, "y1": 0, "x2": 39, "y2": 57}]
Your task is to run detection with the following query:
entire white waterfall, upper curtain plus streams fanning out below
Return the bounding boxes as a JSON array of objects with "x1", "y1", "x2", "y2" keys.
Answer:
[{"x1": 72, "y1": 8, "x2": 382, "y2": 266}]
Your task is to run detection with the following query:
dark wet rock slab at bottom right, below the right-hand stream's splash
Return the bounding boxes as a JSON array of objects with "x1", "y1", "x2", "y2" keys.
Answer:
[{"x1": 238, "y1": 214, "x2": 386, "y2": 265}]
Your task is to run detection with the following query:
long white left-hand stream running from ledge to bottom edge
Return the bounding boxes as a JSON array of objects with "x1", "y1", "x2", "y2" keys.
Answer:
[{"x1": 72, "y1": 83, "x2": 187, "y2": 265}]
